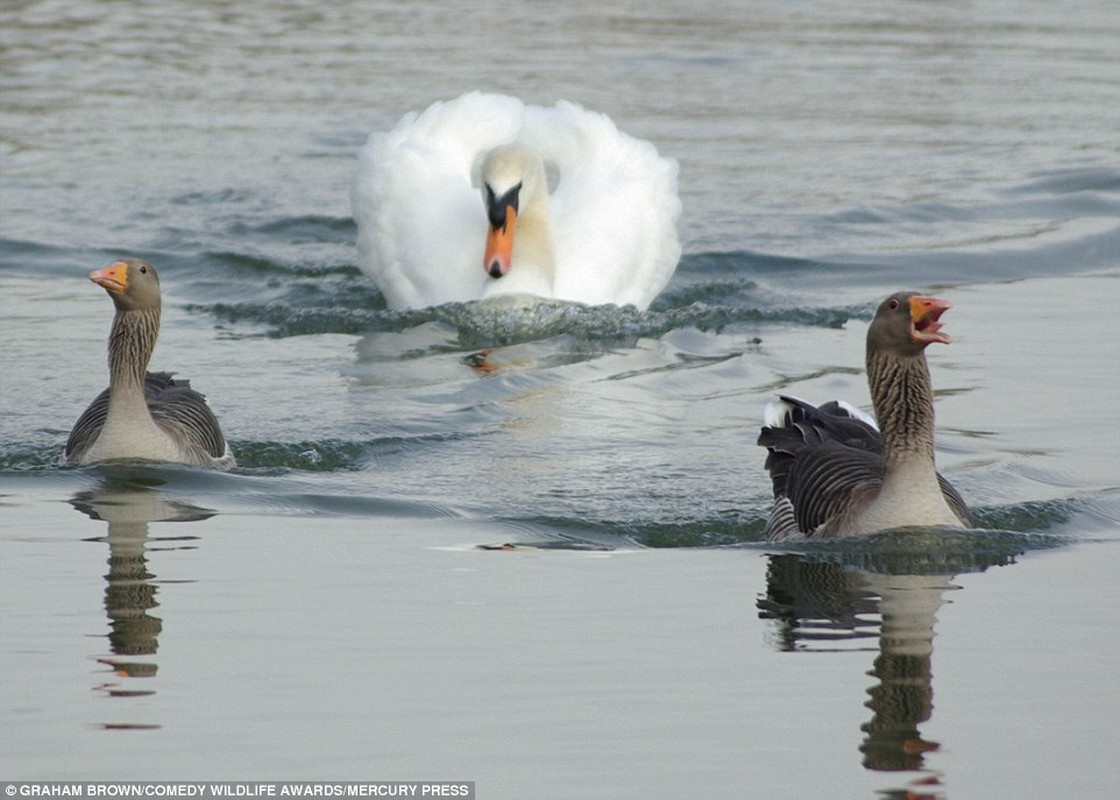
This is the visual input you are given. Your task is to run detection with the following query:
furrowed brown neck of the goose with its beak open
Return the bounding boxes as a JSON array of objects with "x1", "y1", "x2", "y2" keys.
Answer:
[{"x1": 867, "y1": 353, "x2": 940, "y2": 484}]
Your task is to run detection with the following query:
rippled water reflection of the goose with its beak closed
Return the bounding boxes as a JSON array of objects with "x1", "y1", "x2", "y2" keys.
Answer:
[{"x1": 71, "y1": 466, "x2": 214, "y2": 729}]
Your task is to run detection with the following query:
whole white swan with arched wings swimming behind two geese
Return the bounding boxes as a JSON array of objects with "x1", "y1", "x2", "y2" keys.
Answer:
[{"x1": 351, "y1": 92, "x2": 681, "y2": 309}]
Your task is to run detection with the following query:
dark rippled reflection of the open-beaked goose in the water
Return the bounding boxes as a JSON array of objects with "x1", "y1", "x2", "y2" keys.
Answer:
[{"x1": 757, "y1": 532, "x2": 1021, "y2": 800}]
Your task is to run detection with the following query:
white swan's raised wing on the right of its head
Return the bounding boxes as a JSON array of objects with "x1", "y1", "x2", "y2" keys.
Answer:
[{"x1": 521, "y1": 102, "x2": 681, "y2": 308}]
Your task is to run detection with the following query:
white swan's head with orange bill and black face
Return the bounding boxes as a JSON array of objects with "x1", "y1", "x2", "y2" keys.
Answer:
[{"x1": 482, "y1": 145, "x2": 548, "y2": 278}]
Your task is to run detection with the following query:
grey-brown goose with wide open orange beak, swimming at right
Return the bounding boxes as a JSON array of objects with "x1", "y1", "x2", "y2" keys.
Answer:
[{"x1": 758, "y1": 292, "x2": 972, "y2": 540}]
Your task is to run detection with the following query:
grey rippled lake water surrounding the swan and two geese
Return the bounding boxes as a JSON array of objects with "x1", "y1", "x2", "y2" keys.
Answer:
[{"x1": 0, "y1": 0, "x2": 1120, "y2": 798}]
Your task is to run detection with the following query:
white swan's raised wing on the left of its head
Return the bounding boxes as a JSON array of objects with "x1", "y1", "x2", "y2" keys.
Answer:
[{"x1": 351, "y1": 92, "x2": 524, "y2": 308}]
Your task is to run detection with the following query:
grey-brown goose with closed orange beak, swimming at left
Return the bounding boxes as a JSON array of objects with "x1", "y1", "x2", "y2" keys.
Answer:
[{"x1": 63, "y1": 259, "x2": 235, "y2": 468}]
